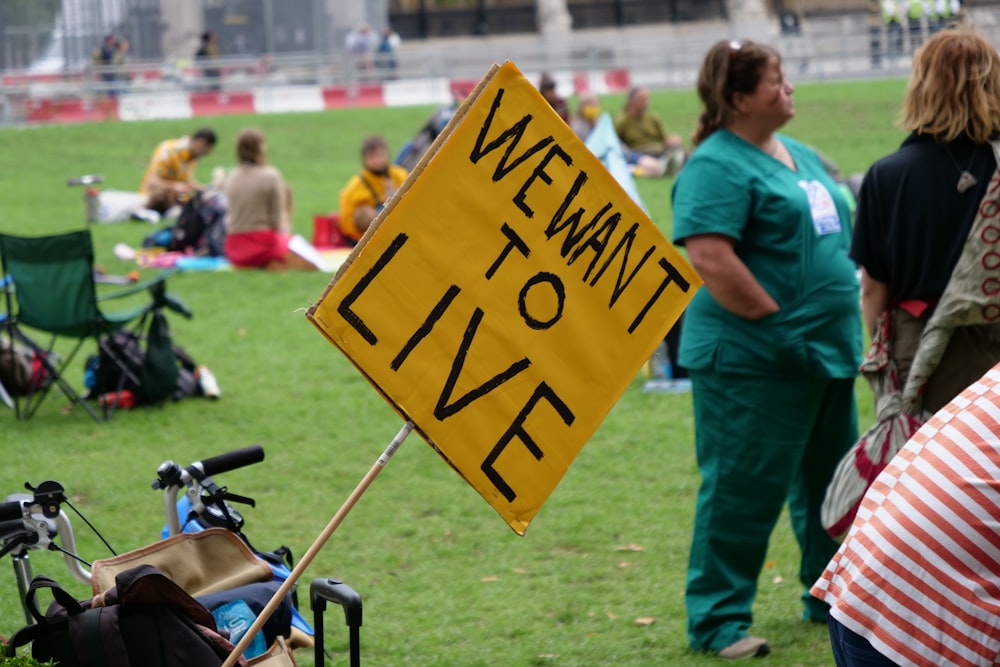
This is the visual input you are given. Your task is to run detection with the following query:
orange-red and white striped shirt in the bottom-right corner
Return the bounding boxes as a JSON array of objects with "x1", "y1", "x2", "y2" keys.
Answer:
[{"x1": 811, "y1": 364, "x2": 1000, "y2": 667}]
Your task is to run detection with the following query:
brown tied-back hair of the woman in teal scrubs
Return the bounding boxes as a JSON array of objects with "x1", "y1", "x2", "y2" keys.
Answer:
[{"x1": 691, "y1": 40, "x2": 781, "y2": 146}]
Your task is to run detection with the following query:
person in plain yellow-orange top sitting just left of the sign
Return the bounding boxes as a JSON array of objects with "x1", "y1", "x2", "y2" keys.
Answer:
[{"x1": 340, "y1": 135, "x2": 408, "y2": 244}]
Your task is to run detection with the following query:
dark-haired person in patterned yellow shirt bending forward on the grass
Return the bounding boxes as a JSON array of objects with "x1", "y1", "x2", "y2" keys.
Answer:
[{"x1": 139, "y1": 127, "x2": 216, "y2": 214}]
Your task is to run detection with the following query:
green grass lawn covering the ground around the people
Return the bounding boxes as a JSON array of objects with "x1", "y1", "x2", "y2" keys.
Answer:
[{"x1": 0, "y1": 75, "x2": 904, "y2": 667}]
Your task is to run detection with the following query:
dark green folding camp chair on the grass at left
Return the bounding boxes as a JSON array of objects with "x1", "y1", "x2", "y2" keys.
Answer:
[{"x1": 0, "y1": 230, "x2": 191, "y2": 421}]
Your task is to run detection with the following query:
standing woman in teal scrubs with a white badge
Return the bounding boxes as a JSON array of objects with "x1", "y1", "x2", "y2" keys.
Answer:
[{"x1": 673, "y1": 41, "x2": 861, "y2": 658}]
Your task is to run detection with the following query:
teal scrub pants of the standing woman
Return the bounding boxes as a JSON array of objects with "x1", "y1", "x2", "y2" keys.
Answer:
[{"x1": 685, "y1": 370, "x2": 858, "y2": 652}]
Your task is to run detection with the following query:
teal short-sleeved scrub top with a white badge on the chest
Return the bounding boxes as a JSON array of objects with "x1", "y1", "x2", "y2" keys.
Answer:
[{"x1": 673, "y1": 130, "x2": 862, "y2": 378}]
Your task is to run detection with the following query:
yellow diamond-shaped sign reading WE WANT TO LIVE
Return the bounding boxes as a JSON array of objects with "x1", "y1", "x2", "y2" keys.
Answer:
[{"x1": 307, "y1": 63, "x2": 701, "y2": 535}]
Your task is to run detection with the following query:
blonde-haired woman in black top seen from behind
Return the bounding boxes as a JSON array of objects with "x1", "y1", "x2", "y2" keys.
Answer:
[{"x1": 851, "y1": 29, "x2": 1000, "y2": 412}]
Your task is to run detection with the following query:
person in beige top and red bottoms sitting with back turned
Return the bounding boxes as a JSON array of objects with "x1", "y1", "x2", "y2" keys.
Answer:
[{"x1": 224, "y1": 128, "x2": 325, "y2": 271}]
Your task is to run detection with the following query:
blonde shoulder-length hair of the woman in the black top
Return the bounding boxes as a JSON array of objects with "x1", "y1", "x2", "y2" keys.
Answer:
[{"x1": 899, "y1": 29, "x2": 1000, "y2": 143}]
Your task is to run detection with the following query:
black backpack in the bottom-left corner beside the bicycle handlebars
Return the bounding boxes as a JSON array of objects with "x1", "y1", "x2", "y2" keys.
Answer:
[{"x1": 6, "y1": 565, "x2": 245, "y2": 667}]
